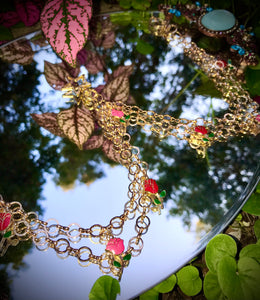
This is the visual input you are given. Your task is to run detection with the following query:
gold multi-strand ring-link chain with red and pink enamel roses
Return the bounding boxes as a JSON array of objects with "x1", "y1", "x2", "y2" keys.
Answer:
[{"x1": 0, "y1": 17, "x2": 259, "y2": 279}]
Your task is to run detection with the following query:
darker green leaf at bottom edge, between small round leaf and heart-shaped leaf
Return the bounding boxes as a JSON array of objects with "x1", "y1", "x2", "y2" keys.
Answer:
[{"x1": 203, "y1": 271, "x2": 225, "y2": 300}]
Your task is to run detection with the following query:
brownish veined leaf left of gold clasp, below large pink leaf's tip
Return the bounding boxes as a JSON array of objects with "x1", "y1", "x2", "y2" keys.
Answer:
[{"x1": 44, "y1": 61, "x2": 70, "y2": 90}]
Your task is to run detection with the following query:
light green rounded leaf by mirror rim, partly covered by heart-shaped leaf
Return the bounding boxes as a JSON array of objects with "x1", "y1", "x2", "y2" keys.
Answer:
[{"x1": 205, "y1": 234, "x2": 237, "y2": 272}]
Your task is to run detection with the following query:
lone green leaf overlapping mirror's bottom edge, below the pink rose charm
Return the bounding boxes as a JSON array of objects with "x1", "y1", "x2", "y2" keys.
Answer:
[{"x1": 89, "y1": 275, "x2": 120, "y2": 300}]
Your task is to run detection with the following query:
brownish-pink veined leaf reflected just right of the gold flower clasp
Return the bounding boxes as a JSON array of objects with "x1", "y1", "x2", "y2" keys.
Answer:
[{"x1": 102, "y1": 76, "x2": 129, "y2": 103}]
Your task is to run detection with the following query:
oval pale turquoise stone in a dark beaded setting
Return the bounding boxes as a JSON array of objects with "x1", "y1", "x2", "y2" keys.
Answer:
[{"x1": 201, "y1": 9, "x2": 236, "y2": 31}]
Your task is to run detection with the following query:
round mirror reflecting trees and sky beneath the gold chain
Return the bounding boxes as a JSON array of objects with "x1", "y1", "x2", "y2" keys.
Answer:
[{"x1": 0, "y1": 0, "x2": 260, "y2": 300}]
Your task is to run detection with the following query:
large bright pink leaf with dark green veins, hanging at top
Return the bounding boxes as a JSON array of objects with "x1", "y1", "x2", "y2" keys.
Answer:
[{"x1": 41, "y1": 0, "x2": 92, "y2": 67}]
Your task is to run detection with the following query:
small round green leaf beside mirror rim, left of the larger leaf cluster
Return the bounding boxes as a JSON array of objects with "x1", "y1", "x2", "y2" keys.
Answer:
[{"x1": 176, "y1": 266, "x2": 202, "y2": 296}]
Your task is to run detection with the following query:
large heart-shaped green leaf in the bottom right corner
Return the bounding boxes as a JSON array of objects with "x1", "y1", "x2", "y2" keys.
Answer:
[{"x1": 217, "y1": 256, "x2": 260, "y2": 300}]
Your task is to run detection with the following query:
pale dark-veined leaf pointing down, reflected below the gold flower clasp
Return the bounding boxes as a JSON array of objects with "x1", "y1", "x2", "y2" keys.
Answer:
[{"x1": 58, "y1": 106, "x2": 94, "y2": 149}]
